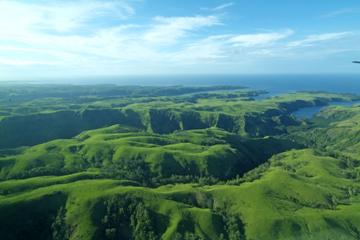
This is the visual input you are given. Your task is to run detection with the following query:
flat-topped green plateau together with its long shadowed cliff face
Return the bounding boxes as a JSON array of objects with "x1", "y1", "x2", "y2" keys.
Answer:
[{"x1": 0, "y1": 88, "x2": 354, "y2": 149}]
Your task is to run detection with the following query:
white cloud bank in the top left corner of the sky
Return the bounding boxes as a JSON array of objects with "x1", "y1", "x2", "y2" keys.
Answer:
[{"x1": 0, "y1": 0, "x2": 134, "y2": 37}]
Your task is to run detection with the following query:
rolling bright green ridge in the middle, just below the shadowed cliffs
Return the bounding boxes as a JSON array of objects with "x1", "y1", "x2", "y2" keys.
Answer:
[{"x1": 0, "y1": 125, "x2": 297, "y2": 181}]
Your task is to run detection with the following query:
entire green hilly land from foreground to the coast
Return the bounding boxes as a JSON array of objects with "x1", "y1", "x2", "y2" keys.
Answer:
[{"x1": 0, "y1": 85, "x2": 360, "y2": 240}]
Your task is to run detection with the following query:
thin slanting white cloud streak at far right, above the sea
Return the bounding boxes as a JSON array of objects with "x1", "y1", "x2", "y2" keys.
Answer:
[{"x1": 288, "y1": 32, "x2": 352, "y2": 47}]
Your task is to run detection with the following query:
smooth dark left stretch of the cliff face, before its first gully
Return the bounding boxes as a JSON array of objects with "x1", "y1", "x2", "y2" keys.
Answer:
[{"x1": 0, "y1": 109, "x2": 144, "y2": 148}]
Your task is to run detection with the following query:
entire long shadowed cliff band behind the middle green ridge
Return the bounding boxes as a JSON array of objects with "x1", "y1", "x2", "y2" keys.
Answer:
[{"x1": 0, "y1": 106, "x2": 295, "y2": 149}]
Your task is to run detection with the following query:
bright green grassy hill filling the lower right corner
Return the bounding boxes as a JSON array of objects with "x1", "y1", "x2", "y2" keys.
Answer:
[{"x1": 214, "y1": 150, "x2": 360, "y2": 239}]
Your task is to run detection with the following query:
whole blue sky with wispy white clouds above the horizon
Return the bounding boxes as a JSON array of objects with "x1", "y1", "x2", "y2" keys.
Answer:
[{"x1": 0, "y1": 0, "x2": 360, "y2": 80}]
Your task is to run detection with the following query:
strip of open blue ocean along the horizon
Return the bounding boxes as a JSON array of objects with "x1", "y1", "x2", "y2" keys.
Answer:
[{"x1": 78, "y1": 74, "x2": 360, "y2": 95}]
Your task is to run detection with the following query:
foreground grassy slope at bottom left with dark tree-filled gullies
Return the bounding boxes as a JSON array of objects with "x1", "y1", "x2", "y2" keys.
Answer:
[{"x1": 0, "y1": 176, "x2": 231, "y2": 239}]
